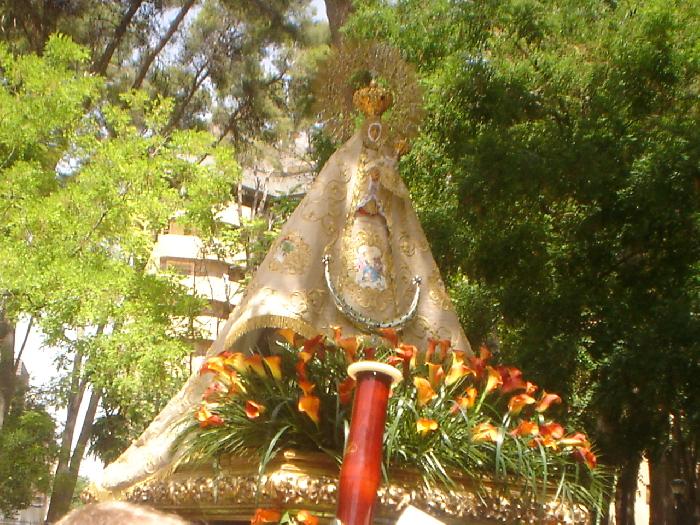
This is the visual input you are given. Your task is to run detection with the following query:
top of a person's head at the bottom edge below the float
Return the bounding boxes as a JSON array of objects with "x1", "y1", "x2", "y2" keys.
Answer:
[{"x1": 56, "y1": 501, "x2": 189, "y2": 525}]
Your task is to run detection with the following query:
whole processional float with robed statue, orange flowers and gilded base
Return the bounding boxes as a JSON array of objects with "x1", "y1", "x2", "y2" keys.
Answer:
[{"x1": 87, "y1": 44, "x2": 593, "y2": 525}]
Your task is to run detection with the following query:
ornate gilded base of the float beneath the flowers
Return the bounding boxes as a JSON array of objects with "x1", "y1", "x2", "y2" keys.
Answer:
[{"x1": 83, "y1": 450, "x2": 588, "y2": 525}]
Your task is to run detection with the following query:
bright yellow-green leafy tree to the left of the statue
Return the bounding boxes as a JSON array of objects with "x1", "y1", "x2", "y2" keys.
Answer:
[{"x1": 0, "y1": 37, "x2": 239, "y2": 520}]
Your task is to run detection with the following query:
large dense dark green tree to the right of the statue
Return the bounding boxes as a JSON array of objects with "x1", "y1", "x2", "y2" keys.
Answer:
[{"x1": 348, "y1": 0, "x2": 700, "y2": 523}]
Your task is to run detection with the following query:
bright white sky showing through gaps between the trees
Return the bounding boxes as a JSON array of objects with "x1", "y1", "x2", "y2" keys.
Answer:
[{"x1": 15, "y1": 0, "x2": 326, "y2": 483}]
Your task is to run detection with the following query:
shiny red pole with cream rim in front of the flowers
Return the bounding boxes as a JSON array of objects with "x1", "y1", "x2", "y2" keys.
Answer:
[{"x1": 336, "y1": 361, "x2": 401, "y2": 525}]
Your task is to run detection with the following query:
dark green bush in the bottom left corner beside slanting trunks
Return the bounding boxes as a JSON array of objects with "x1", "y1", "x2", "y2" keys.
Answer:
[{"x1": 0, "y1": 403, "x2": 56, "y2": 517}]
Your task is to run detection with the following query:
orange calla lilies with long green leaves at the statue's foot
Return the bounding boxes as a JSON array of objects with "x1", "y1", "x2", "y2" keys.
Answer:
[{"x1": 176, "y1": 329, "x2": 607, "y2": 523}]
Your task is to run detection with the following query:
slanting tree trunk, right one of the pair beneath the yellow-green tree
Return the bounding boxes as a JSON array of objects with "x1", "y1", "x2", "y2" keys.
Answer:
[{"x1": 47, "y1": 389, "x2": 102, "y2": 523}]
